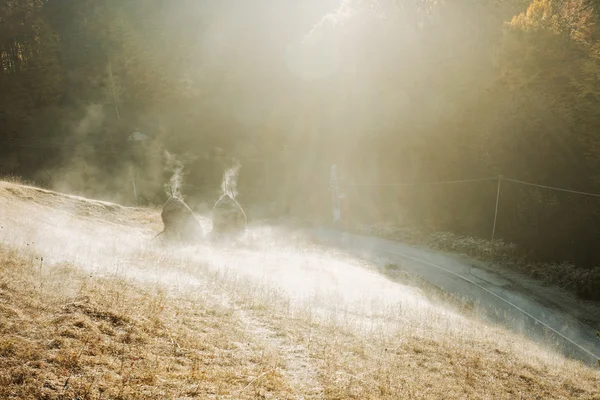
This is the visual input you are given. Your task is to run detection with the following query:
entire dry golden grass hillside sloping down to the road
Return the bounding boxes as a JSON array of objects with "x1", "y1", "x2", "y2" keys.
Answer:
[{"x1": 0, "y1": 183, "x2": 600, "y2": 399}]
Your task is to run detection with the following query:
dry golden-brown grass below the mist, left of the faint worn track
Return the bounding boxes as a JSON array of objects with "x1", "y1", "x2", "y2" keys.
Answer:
[{"x1": 0, "y1": 250, "x2": 292, "y2": 399}]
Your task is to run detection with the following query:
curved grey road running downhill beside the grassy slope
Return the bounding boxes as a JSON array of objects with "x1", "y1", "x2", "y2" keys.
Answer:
[{"x1": 310, "y1": 229, "x2": 600, "y2": 365}]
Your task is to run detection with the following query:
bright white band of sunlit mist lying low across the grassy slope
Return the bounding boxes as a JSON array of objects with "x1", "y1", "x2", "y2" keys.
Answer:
[{"x1": 0, "y1": 179, "x2": 558, "y2": 357}]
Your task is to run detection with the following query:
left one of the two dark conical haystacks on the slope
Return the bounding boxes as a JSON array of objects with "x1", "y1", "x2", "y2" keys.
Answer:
[{"x1": 160, "y1": 197, "x2": 202, "y2": 241}]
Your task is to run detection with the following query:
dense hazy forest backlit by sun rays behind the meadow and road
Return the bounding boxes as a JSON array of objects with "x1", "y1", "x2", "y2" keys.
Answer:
[{"x1": 0, "y1": 0, "x2": 600, "y2": 276}]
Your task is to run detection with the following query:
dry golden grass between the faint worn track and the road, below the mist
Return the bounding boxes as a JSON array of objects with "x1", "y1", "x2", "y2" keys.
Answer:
[{"x1": 207, "y1": 270, "x2": 600, "y2": 400}]
